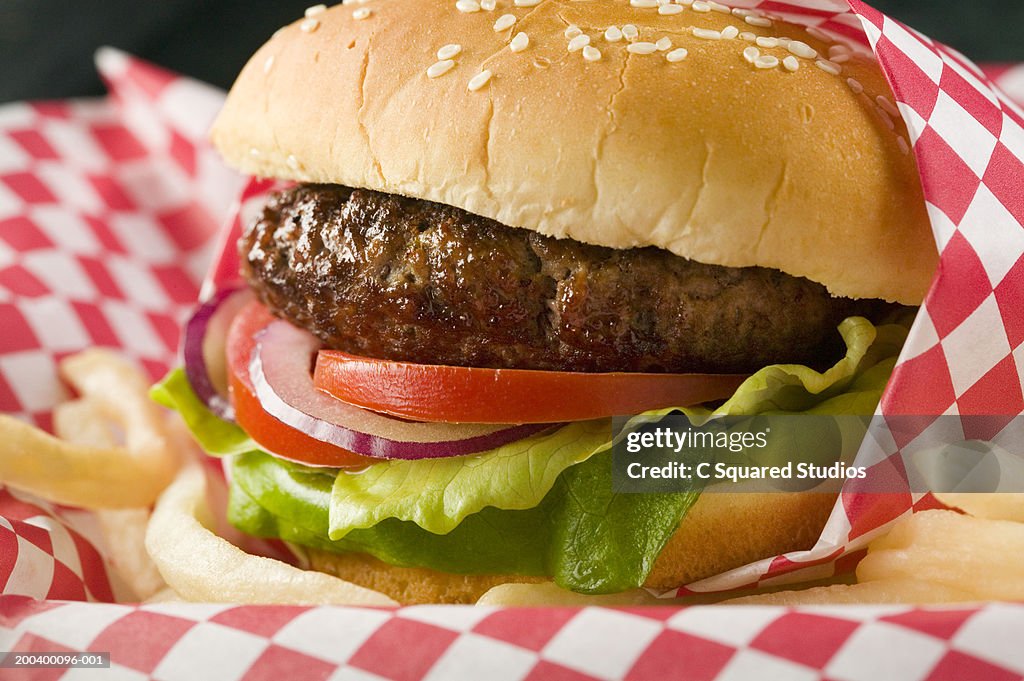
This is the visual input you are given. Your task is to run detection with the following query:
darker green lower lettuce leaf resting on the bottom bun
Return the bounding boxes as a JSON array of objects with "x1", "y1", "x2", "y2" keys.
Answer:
[{"x1": 228, "y1": 452, "x2": 698, "y2": 593}]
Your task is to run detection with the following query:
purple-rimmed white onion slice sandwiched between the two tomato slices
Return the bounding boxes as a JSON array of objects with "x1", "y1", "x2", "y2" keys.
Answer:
[{"x1": 249, "y1": 322, "x2": 557, "y2": 459}]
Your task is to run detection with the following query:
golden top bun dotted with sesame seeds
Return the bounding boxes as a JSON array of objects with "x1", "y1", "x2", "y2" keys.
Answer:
[{"x1": 212, "y1": 0, "x2": 937, "y2": 304}]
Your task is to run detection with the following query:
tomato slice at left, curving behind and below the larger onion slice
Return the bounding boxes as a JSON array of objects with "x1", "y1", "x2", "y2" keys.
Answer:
[{"x1": 227, "y1": 302, "x2": 377, "y2": 468}]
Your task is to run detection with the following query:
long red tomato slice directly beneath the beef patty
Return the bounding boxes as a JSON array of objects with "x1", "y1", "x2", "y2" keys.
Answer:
[{"x1": 313, "y1": 350, "x2": 746, "y2": 424}]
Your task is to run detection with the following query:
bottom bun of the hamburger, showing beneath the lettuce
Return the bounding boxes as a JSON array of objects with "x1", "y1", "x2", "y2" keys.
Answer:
[{"x1": 308, "y1": 493, "x2": 836, "y2": 605}]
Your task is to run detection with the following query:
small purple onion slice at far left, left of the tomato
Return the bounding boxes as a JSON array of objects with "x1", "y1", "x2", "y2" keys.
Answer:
[{"x1": 181, "y1": 288, "x2": 252, "y2": 421}]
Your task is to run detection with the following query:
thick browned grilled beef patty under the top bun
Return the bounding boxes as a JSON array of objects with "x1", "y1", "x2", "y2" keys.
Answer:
[{"x1": 240, "y1": 184, "x2": 892, "y2": 373}]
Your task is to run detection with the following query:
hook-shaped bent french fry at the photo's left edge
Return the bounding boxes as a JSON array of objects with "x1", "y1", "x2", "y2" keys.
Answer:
[{"x1": 0, "y1": 350, "x2": 178, "y2": 509}]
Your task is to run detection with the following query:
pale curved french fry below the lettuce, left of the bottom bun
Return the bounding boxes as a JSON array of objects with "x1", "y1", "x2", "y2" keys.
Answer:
[{"x1": 145, "y1": 464, "x2": 397, "y2": 605}]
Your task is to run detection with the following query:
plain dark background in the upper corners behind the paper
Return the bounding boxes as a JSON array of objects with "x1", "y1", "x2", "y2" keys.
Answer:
[{"x1": 0, "y1": 0, "x2": 1024, "y2": 102}]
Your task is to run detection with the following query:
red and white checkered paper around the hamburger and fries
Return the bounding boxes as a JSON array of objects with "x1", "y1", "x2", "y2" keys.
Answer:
[{"x1": 0, "y1": 0, "x2": 1024, "y2": 680}]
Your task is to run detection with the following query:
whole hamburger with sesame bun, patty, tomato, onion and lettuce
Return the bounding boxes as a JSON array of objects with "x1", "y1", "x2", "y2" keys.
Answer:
[{"x1": 158, "y1": 0, "x2": 937, "y2": 603}]
